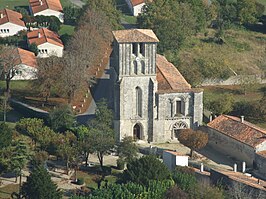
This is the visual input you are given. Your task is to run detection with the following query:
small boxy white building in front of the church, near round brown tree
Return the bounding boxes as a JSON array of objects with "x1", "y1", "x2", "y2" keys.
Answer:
[{"x1": 163, "y1": 151, "x2": 188, "y2": 170}]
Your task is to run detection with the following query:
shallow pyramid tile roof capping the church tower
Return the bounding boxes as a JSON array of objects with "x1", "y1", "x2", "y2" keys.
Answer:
[{"x1": 113, "y1": 29, "x2": 159, "y2": 43}]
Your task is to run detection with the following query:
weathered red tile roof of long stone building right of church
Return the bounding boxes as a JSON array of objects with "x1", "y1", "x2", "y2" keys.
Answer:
[{"x1": 207, "y1": 115, "x2": 266, "y2": 147}]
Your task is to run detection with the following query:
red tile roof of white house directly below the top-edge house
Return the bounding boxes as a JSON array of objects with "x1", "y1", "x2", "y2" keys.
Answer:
[{"x1": 27, "y1": 28, "x2": 64, "y2": 47}]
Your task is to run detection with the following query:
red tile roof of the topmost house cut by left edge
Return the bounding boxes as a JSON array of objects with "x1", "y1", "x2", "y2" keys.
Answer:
[{"x1": 0, "y1": 9, "x2": 25, "y2": 27}]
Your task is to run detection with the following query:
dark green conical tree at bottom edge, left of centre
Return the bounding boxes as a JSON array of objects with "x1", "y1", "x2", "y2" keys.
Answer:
[{"x1": 22, "y1": 167, "x2": 62, "y2": 199}]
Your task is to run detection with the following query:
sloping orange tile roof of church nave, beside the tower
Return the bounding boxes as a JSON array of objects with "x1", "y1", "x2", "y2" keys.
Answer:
[{"x1": 156, "y1": 54, "x2": 191, "y2": 91}]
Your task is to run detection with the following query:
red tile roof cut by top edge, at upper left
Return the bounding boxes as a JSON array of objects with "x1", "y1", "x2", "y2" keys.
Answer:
[{"x1": 29, "y1": 0, "x2": 63, "y2": 14}]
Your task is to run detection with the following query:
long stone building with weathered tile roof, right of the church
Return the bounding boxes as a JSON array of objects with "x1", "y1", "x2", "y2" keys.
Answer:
[{"x1": 207, "y1": 115, "x2": 266, "y2": 166}]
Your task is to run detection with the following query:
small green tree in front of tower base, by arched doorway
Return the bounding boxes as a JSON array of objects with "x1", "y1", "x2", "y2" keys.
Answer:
[{"x1": 117, "y1": 137, "x2": 138, "y2": 162}]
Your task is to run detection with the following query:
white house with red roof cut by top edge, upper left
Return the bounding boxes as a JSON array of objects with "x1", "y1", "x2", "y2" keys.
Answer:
[{"x1": 29, "y1": 0, "x2": 64, "y2": 23}]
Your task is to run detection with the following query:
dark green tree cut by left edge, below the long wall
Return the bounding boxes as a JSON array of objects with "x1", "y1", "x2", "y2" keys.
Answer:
[{"x1": 0, "y1": 122, "x2": 13, "y2": 150}]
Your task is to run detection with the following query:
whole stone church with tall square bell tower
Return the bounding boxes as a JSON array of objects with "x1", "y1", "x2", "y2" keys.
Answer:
[{"x1": 110, "y1": 29, "x2": 203, "y2": 142}]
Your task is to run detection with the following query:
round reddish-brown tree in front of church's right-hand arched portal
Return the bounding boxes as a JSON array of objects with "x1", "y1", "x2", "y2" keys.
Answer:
[{"x1": 178, "y1": 129, "x2": 208, "y2": 157}]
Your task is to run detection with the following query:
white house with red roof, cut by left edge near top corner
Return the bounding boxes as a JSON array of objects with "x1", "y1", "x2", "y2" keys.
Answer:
[{"x1": 0, "y1": 9, "x2": 27, "y2": 37}]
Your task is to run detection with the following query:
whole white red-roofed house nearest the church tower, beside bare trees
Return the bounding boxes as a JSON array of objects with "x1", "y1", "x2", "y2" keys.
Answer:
[{"x1": 27, "y1": 28, "x2": 64, "y2": 58}]
